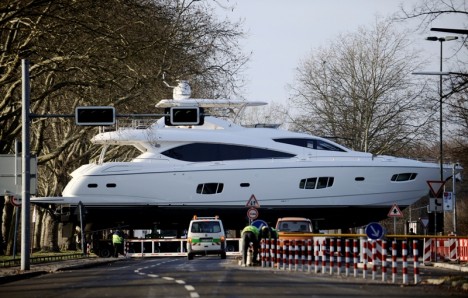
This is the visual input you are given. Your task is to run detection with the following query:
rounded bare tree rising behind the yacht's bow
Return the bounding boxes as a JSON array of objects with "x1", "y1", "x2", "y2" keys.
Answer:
[{"x1": 291, "y1": 21, "x2": 430, "y2": 154}]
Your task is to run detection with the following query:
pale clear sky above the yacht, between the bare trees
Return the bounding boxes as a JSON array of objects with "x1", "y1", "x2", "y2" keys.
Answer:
[{"x1": 215, "y1": 0, "x2": 467, "y2": 103}]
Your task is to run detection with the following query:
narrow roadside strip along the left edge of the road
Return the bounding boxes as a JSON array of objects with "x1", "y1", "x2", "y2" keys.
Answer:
[{"x1": 0, "y1": 257, "x2": 125, "y2": 285}]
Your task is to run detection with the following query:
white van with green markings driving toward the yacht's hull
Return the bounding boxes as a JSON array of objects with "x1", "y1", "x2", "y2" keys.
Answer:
[{"x1": 187, "y1": 216, "x2": 226, "y2": 260}]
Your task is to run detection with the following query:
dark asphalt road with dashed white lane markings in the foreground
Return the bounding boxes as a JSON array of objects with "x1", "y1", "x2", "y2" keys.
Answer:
[{"x1": 0, "y1": 256, "x2": 466, "y2": 298}]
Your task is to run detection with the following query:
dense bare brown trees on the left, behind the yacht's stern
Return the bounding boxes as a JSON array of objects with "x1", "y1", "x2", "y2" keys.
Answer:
[{"x1": 0, "y1": 0, "x2": 247, "y2": 250}]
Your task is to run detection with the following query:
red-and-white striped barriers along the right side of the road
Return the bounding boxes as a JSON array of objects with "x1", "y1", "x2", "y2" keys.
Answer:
[{"x1": 259, "y1": 237, "x2": 468, "y2": 284}]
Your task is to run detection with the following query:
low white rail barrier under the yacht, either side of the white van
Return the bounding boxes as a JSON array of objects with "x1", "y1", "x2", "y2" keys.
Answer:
[{"x1": 124, "y1": 238, "x2": 241, "y2": 258}]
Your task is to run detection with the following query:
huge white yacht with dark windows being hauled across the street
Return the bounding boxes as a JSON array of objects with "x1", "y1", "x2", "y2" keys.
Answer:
[{"x1": 32, "y1": 81, "x2": 460, "y2": 228}]
